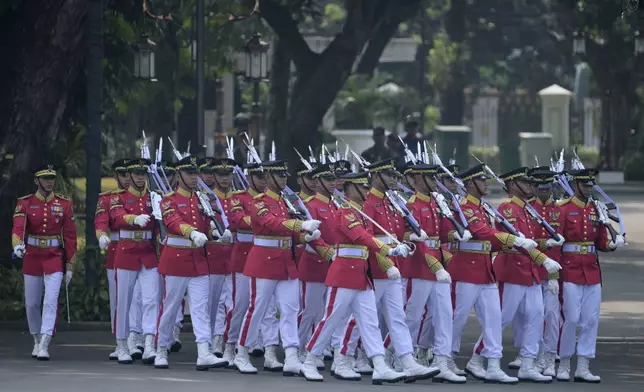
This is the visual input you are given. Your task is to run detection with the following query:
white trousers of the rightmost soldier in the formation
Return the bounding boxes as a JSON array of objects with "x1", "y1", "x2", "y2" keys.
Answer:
[{"x1": 559, "y1": 282, "x2": 602, "y2": 359}]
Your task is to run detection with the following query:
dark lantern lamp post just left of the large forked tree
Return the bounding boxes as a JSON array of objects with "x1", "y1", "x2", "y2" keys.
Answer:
[{"x1": 244, "y1": 33, "x2": 269, "y2": 142}]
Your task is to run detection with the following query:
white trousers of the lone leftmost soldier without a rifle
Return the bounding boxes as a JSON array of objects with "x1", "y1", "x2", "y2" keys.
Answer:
[{"x1": 24, "y1": 272, "x2": 63, "y2": 336}]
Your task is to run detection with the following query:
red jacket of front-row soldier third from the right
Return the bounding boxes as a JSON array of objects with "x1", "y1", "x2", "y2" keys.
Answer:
[{"x1": 449, "y1": 195, "x2": 516, "y2": 284}]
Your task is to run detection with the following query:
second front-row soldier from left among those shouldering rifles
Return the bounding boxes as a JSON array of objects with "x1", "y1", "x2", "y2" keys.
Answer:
[{"x1": 154, "y1": 157, "x2": 228, "y2": 370}]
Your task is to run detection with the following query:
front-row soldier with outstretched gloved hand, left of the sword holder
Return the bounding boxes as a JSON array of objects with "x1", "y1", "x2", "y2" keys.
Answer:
[{"x1": 234, "y1": 160, "x2": 320, "y2": 376}]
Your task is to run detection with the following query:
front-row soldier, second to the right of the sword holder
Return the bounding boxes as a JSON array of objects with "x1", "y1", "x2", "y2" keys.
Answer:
[{"x1": 401, "y1": 164, "x2": 471, "y2": 384}]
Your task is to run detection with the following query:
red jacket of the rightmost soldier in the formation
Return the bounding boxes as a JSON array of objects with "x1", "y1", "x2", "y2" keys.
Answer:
[{"x1": 560, "y1": 197, "x2": 611, "y2": 285}]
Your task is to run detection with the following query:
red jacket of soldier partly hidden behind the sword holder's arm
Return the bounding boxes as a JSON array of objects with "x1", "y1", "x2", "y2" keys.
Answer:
[{"x1": 362, "y1": 188, "x2": 405, "y2": 279}]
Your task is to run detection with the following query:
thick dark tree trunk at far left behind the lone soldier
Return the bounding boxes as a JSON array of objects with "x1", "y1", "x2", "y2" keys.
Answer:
[{"x1": 0, "y1": 0, "x2": 87, "y2": 264}]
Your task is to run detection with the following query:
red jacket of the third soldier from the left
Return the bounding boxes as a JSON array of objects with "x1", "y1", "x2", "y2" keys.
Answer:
[{"x1": 110, "y1": 186, "x2": 157, "y2": 271}]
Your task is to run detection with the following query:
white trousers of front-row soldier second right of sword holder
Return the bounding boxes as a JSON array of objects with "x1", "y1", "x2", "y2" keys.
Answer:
[{"x1": 405, "y1": 279, "x2": 453, "y2": 357}]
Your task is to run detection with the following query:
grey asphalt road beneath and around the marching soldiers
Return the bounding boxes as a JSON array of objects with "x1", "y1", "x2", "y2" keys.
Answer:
[{"x1": 0, "y1": 194, "x2": 644, "y2": 392}]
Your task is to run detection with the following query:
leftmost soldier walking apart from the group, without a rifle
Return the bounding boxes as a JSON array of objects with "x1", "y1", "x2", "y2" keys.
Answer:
[{"x1": 11, "y1": 165, "x2": 76, "y2": 361}]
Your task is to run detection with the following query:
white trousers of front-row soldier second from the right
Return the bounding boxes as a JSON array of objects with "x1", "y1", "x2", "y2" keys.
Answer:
[{"x1": 474, "y1": 283, "x2": 543, "y2": 358}]
